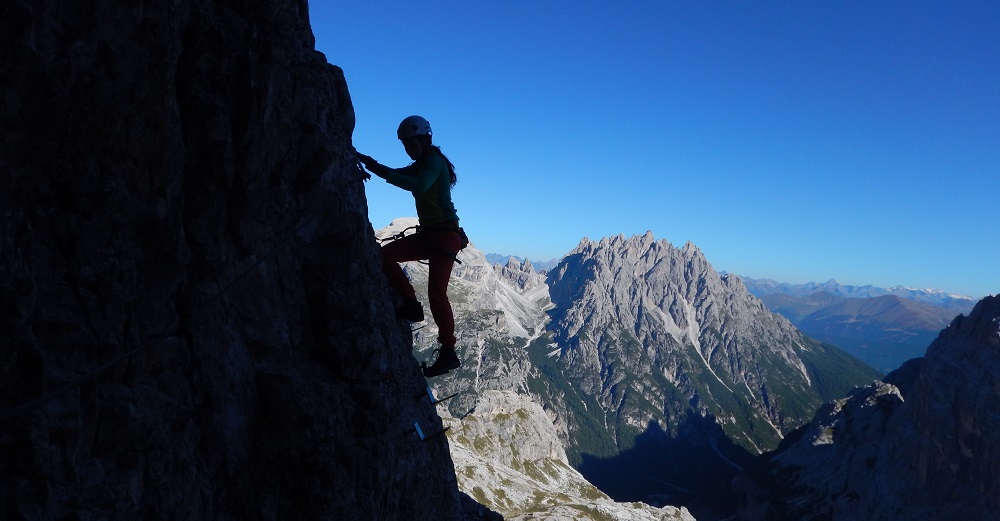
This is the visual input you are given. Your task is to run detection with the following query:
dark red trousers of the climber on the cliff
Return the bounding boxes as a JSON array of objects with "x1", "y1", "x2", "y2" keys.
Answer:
[{"x1": 382, "y1": 227, "x2": 462, "y2": 349}]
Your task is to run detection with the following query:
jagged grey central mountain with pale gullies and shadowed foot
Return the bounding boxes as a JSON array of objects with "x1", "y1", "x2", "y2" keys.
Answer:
[{"x1": 548, "y1": 233, "x2": 876, "y2": 508}]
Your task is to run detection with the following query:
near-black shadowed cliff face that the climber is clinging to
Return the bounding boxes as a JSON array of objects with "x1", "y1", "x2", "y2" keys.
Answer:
[{"x1": 0, "y1": 0, "x2": 480, "y2": 520}]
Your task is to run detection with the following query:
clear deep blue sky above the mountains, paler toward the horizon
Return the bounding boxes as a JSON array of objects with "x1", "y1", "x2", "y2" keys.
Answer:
[{"x1": 309, "y1": 0, "x2": 1000, "y2": 298}]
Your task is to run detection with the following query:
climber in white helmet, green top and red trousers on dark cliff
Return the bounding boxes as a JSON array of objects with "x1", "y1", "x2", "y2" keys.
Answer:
[{"x1": 358, "y1": 116, "x2": 467, "y2": 377}]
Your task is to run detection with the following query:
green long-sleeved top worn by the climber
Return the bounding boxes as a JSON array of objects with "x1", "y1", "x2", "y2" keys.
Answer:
[{"x1": 372, "y1": 152, "x2": 458, "y2": 226}]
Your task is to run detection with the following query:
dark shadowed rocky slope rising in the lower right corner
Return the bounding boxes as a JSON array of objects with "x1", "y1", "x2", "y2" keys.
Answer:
[{"x1": 736, "y1": 297, "x2": 1000, "y2": 520}]
